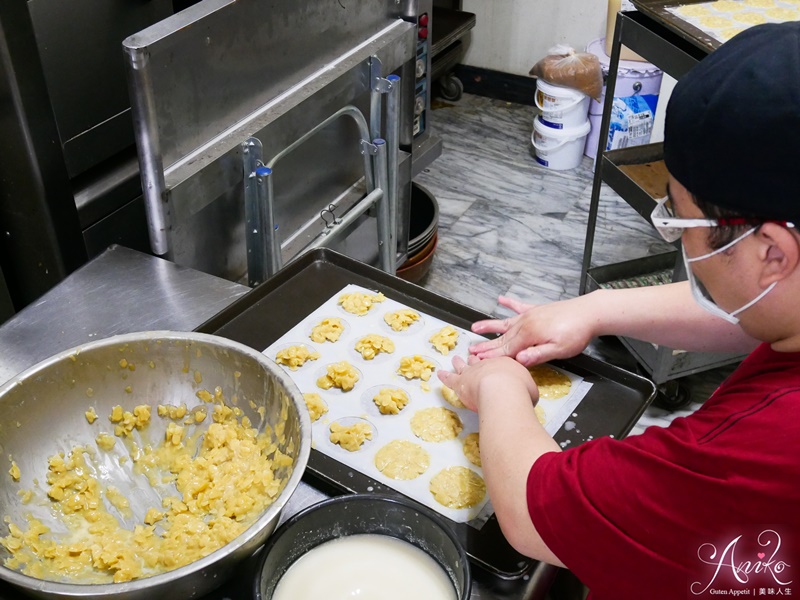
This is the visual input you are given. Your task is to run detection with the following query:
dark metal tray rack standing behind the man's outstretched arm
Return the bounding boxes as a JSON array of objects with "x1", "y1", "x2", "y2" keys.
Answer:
[{"x1": 580, "y1": 10, "x2": 742, "y2": 385}]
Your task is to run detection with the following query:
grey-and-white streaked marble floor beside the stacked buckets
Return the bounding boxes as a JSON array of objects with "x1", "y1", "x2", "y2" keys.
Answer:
[{"x1": 415, "y1": 94, "x2": 731, "y2": 433}]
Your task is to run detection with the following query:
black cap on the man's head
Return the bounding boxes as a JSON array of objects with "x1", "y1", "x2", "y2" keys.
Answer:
[{"x1": 664, "y1": 22, "x2": 800, "y2": 222}]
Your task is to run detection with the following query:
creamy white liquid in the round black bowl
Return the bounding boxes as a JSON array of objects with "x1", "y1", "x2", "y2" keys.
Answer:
[{"x1": 272, "y1": 534, "x2": 456, "y2": 600}]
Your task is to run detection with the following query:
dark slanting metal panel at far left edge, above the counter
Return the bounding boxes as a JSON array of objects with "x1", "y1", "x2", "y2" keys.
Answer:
[{"x1": 0, "y1": 0, "x2": 86, "y2": 310}]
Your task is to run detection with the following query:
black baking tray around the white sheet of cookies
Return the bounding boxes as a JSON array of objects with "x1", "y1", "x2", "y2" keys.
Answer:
[{"x1": 197, "y1": 248, "x2": 655, "y2": 580}]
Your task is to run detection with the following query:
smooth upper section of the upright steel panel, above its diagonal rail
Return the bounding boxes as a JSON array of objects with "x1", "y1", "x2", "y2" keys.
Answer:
[{"x1": 123, "y1": 0, "x2": 416, "y2": 173}]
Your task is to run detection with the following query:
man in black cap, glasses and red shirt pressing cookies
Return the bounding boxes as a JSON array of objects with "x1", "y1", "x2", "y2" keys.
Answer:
[{"x1": 440, "y1": 23, "x2": 800, "y2": 600}]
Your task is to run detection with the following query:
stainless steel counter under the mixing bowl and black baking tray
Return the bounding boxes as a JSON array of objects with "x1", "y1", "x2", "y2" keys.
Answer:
[{"x1": 0, "y1": 246, "x2": 555, "y2": 600}]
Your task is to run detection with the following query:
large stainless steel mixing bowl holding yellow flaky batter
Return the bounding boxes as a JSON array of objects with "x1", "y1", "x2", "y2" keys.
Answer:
[{"x1": 0, "y1": 331, "x2": 311, "y2": 600}]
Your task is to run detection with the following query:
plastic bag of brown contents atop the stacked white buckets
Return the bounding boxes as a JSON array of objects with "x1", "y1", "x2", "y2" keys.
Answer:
[{"x1": 529, "y1": 45, "x2": 603, "y2": 101}]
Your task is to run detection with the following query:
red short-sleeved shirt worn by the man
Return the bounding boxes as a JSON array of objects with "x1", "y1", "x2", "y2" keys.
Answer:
[{"x1": 527, "y1": 344, "x2": 800, "y2": 600}]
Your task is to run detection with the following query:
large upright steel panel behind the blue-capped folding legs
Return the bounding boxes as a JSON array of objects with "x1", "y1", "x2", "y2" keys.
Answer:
[{"x1": 124, "y1": 0, "x2": 416, "y2": 280}]
